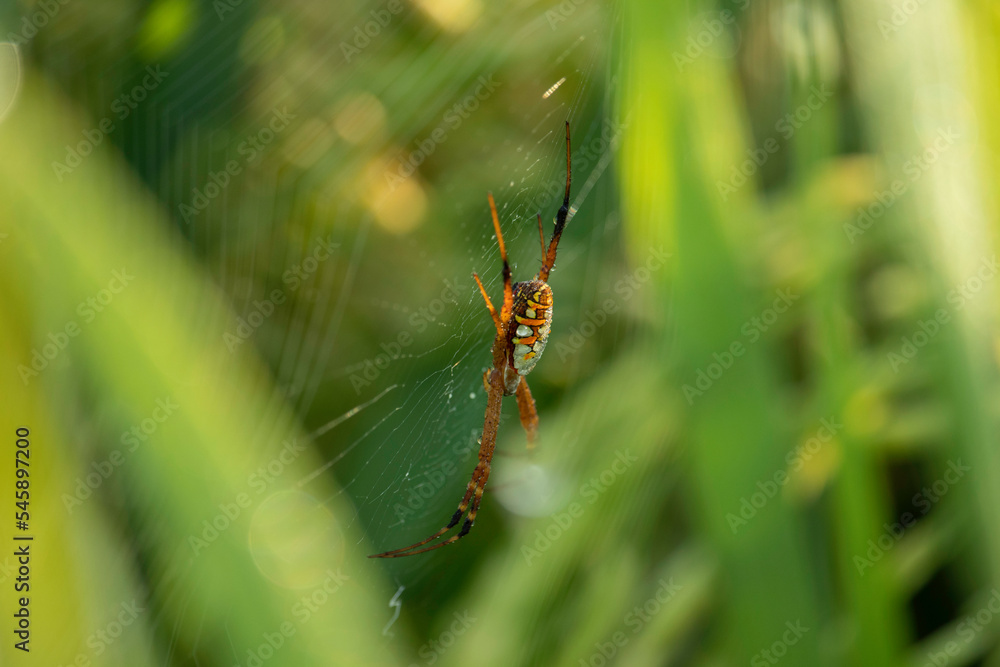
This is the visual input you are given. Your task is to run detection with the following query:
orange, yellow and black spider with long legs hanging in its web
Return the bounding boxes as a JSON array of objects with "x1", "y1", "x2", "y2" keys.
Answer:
[{"x1": 369, "y1": 121, "x2": 570, "y2": 558}]
